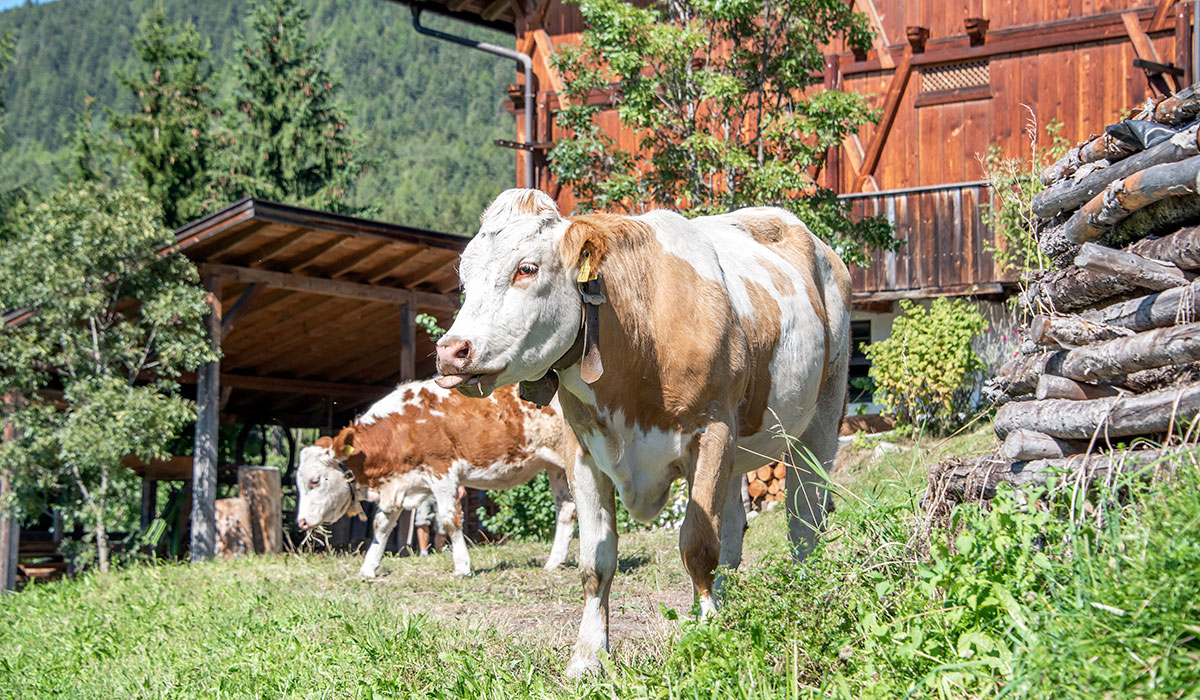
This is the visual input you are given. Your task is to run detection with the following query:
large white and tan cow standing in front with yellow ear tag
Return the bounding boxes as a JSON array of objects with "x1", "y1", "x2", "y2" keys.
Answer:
[{"x1": 438, "y1": 190, "x2": 850, "y2": 675}]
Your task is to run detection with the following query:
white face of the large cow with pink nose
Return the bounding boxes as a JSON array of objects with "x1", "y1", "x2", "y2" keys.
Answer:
[{"x1": 438, "y1": 190, "x2": 582, "y2": 397}]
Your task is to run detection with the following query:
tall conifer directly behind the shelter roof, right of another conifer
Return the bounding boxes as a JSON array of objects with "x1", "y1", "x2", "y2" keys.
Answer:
[{"x1": 216, "y1": 0, "x2": 367, "y2": 214}]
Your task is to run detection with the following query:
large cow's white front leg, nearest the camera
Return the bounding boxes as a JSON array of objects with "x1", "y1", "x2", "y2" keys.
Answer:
[{"x1": 566, "y1": 455, "x2": 617, "y2": 677}]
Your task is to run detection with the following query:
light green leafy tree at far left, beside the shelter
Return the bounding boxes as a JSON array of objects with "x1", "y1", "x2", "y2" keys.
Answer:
[{"x1": 0, "y1": 181, "x2": 212, "y2": 569}]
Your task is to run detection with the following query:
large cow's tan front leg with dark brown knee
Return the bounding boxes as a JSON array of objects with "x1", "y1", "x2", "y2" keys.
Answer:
[{"x1": 679, "y1": 418, "x2": 740, "y2": 620}]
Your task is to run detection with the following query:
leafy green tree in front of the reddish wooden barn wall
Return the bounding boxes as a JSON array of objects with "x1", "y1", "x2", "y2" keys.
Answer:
[{"x1": 551, "y1": 0, "x2": 899, "y2": 263}]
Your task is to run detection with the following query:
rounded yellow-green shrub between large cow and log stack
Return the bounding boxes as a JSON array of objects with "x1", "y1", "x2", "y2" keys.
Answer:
[{"x1": 865, "y1": 298, "x2": 988, "y2": 432}]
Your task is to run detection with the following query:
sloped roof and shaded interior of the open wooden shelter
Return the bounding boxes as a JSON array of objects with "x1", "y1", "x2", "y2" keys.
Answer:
[{"x1": 175, "y1": 198, "x2": 469, "y2": 426}]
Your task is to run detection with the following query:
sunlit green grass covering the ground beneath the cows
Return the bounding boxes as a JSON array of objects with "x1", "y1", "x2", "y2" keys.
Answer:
[{"x1": 0, "y1": 430, "x2": 1200, "y2": 699}]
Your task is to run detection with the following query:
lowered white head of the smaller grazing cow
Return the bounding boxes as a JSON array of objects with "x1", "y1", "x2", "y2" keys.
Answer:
[{"x1": 296, "y1": 427, "x2": 361, "y2": 530}]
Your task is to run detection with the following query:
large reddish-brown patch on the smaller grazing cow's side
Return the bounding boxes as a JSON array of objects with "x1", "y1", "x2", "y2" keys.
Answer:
[{"x1": 326, "y1": 387, "x2": 547, "y2": 487}]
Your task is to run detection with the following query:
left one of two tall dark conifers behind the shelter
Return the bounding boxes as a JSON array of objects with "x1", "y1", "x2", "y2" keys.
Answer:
[{"x1": 109, "y1": 7, "x2": 217, "y2": 228}]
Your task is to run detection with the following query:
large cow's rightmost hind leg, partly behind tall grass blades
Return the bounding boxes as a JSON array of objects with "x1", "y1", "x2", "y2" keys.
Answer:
[{"x1": 785, "y1": 369, "x2": 846, "y2": 560}]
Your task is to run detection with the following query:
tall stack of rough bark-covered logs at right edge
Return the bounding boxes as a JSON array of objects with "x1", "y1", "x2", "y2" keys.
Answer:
[{"x1": 938, "y1": 89, "x2": 1200, "y2": 498}]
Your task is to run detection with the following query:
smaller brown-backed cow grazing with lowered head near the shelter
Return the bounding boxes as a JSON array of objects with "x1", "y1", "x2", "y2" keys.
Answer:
[{"x1": 296, "y1": 381, "x2": 578, "y2": 579}]
